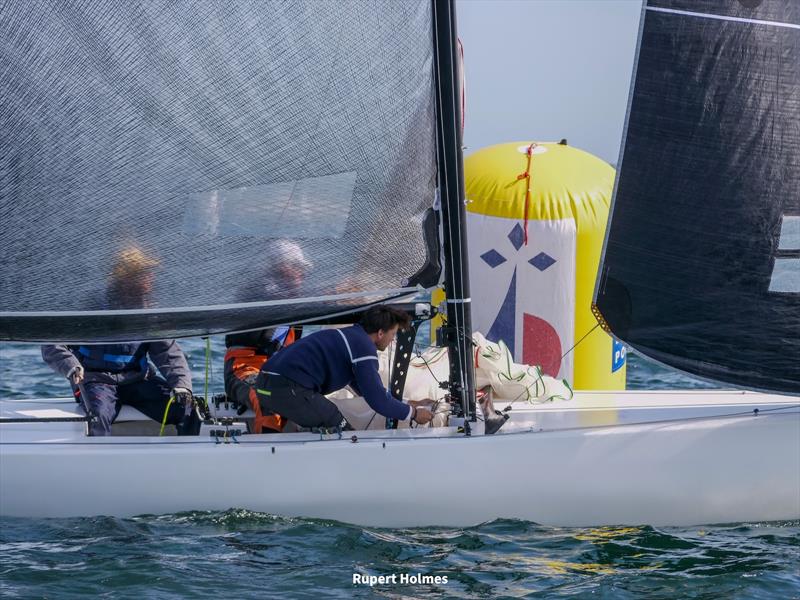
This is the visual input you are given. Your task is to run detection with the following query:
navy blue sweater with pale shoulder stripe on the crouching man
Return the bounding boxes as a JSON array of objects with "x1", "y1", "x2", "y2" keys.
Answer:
[{"x1": 262, "y1": 325, "x2": 411, "y2": 421}]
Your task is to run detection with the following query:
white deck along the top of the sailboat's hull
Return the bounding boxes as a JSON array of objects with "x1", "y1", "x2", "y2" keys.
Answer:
[{"x1": 0, "y1": 390, "x2": 800, "y2": 444}]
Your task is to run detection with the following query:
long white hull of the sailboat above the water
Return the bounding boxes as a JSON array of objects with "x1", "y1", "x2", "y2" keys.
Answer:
[{"x1": 0, "y1": 391, "x2": 800, "y2": 527}]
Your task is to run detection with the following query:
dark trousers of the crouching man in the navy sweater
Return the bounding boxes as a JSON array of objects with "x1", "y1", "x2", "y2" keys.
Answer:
[{"x1": 256, "y1": 371, "x2": 343, "y2": 429}]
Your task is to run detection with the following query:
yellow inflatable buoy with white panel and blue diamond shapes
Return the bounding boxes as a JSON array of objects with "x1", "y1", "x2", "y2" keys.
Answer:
[{"x1": 464, "y1": 141, "x2": 625, "y2": 389}]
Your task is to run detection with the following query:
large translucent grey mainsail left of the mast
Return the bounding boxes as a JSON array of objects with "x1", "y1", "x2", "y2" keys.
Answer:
[{"x1": 0, "y1": 0, "x2": 440, "y2": 342}]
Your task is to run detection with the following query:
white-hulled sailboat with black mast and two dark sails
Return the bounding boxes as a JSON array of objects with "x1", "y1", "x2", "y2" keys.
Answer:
[{"x1": 0, "y1": 0, "x2": 800, "y2": 526}]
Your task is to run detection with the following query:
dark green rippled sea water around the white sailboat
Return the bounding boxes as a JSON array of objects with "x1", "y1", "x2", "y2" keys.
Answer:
[{"x1": 0, "y1": 340, "x2": 800, "y2": 600}]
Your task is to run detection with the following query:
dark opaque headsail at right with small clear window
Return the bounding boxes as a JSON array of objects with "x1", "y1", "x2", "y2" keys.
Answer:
[{"x1": 595, "y1": 0, "x2": 800, "y2": 394}]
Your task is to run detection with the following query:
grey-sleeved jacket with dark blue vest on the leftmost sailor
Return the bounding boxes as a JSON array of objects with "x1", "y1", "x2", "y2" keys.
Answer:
[{"x1": 42, "y1": 340, "x2": 192, "y2": 391}]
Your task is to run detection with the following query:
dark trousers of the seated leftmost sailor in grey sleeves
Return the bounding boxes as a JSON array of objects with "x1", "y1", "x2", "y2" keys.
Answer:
[{"x1": 80, "y1": 379, "x2": 199, "y2": 435}]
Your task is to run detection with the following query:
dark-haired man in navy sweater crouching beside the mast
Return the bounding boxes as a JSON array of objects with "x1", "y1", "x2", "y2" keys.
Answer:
[{"x1": 256, "y1": 305, "x2": 432, "y2": 428}]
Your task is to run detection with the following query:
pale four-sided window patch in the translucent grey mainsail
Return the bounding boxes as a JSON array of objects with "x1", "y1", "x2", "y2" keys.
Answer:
[{"x1": 183, "y1": 171, "x2": 356, "y2": 238}]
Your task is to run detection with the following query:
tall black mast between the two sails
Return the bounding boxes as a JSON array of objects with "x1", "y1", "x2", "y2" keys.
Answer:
[{"x1": 431, "y1": 0, "x2": 475, "y2": 422}]
